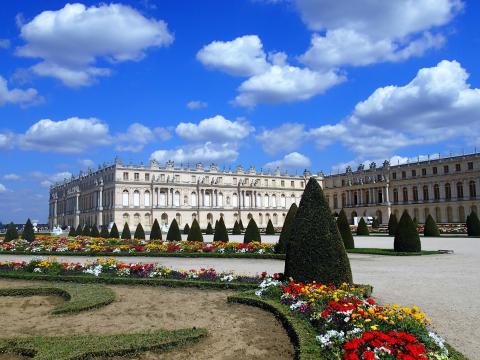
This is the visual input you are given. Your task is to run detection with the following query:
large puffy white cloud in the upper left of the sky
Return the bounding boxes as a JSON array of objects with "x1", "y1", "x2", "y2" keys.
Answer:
[{"x1": 16, "y1": 3, "x2": 173, "y2": 86}]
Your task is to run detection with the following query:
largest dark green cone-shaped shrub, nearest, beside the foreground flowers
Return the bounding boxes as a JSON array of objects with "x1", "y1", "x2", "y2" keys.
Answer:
[{"x1": 285, "y1": 178, "x2": 352, "y2": 286}]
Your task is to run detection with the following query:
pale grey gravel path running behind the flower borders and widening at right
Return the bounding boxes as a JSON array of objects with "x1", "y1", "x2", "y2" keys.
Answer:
[{"x1": 0, "y1": 236, "x2": 480, "y2": 360}]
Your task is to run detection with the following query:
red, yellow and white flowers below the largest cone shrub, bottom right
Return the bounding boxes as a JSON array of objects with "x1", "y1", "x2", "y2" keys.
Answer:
[{"x1": 255, "y1": 278, "x2": 462, "y2": 360}]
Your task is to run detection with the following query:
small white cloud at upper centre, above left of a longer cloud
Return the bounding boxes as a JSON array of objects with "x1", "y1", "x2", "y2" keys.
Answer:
[{"x1": 197, "y1": 35, "x2": 269, "y2": 76}]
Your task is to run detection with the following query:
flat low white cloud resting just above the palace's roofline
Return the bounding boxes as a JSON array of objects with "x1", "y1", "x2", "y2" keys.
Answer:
[{"x1": 150, "y1": 142, "x2": 238, "y2": 165}]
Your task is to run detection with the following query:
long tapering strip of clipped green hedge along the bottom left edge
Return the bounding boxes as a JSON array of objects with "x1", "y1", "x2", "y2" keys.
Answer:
[{"x1": 0, "y1": 328, "x2": 207, "y2": 360}]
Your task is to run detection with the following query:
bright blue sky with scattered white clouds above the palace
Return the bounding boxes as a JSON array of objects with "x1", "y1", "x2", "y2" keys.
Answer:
[{"x1": 0, "y1": 0, "x2": 480, "y2": 222}]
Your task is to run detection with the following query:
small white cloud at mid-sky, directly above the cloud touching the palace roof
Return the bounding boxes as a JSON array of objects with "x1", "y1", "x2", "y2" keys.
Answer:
[{"x1": 175, "y1": 115, "x2": 255, "y2": 143}]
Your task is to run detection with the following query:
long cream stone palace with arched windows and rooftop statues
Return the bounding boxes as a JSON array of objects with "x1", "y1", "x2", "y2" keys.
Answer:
[{"x1": 49, "y1": 154, "x2": 480, "y2": 231}]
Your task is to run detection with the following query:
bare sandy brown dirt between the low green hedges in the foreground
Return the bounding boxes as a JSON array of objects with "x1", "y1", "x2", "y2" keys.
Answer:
[{"x1": 0, "y1": 280, "x2": 293, "y2": 360}]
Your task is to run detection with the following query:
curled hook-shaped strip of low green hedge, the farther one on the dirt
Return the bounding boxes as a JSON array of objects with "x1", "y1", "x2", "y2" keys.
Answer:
[{"x1": 0, "y1": 283, "x2": 115, "y2": 315}]
